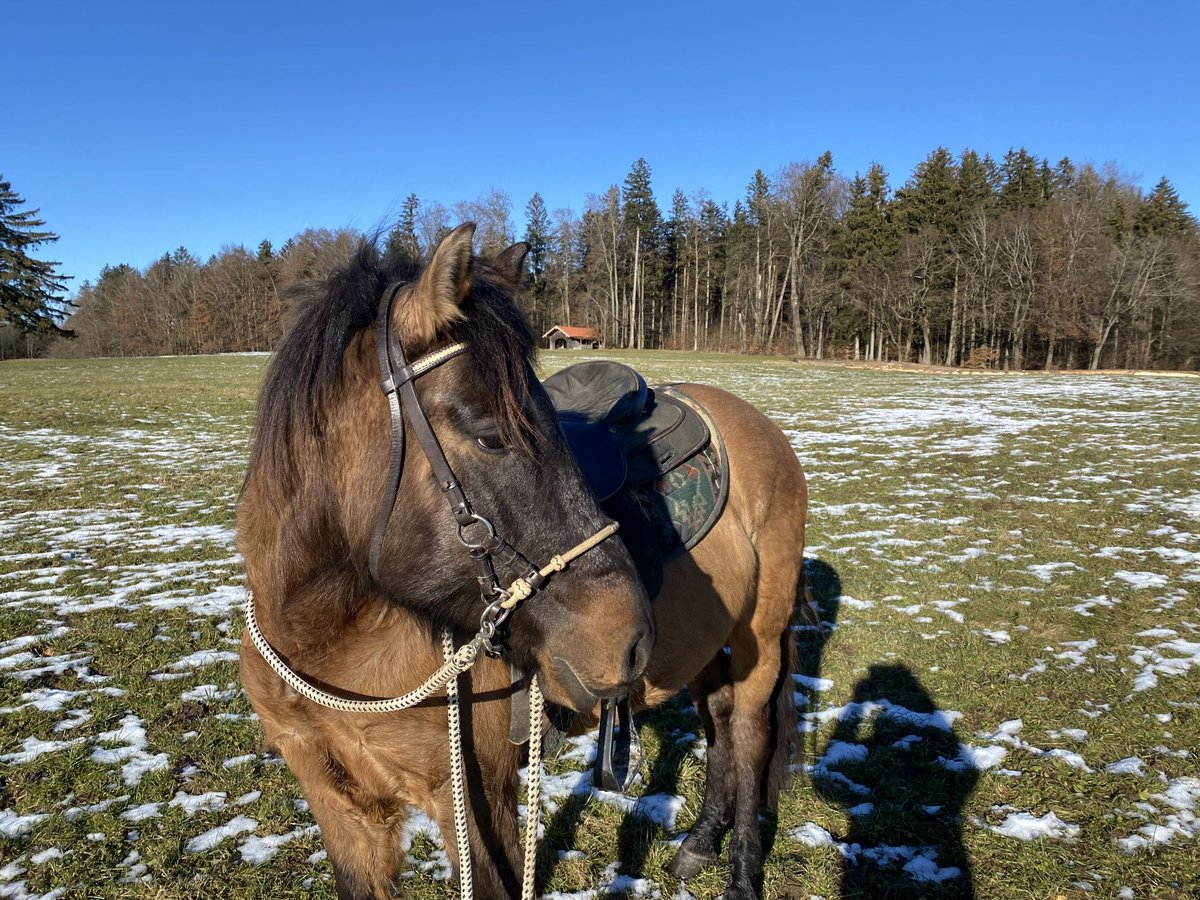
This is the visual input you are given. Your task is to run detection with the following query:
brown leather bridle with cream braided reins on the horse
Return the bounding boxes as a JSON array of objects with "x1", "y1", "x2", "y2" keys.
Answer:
[{"x1": 245, "y1": 286, "x2": 618, "y2": 900}]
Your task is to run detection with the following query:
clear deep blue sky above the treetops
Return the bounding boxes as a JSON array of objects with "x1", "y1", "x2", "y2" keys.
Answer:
[{"x1": 0, "y1": 0, "x2": 1200, "y2": 290}]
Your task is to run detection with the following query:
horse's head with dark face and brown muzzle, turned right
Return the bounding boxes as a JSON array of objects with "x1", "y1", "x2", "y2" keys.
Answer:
[{"x1": 247, "y1": 224, "x2": 654, "y2": 709}]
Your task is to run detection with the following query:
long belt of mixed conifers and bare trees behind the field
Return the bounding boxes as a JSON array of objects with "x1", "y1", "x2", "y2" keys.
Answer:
[{"x1": 40, "y1": 148, "x2": 1200, "y2": 370}]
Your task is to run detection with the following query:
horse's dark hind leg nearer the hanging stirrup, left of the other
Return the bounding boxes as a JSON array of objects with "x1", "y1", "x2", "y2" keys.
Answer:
[{"x1": 668, "y1": 650, "x2": 737, "y2": 880}]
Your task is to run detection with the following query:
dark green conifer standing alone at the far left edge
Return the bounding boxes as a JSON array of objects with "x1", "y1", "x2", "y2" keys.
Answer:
[{"x1": 0, "y1": 176, "x2": 73, "y2": 337}]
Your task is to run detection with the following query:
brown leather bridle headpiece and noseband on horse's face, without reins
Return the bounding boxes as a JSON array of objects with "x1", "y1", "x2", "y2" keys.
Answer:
[{"x1": 370, "y1": 284, "x2": 617, "y2": 656}]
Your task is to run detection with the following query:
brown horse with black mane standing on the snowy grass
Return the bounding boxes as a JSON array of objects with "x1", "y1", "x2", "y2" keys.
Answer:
[{"x1": 238, "y1": 223, "x2": 806, "y2": 899}]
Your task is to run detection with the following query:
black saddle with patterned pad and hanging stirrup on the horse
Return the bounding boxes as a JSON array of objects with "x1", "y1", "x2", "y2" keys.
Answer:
[{"x1": 537, "y1": 360, "x2": 730, "y2": 792}]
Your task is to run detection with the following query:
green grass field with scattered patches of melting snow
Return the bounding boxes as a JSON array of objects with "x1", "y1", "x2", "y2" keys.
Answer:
[{"x1": 0, "y1": 354, "x2": 1200, "y2": 898}]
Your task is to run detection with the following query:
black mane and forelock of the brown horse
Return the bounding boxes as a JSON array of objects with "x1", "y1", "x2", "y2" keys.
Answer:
[{"x1": 247, "y1": 238, "x2": 536, "y2": 496}]
